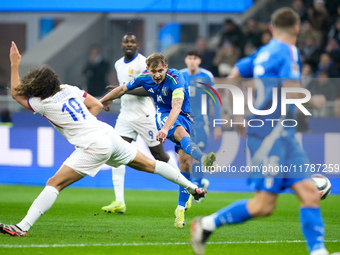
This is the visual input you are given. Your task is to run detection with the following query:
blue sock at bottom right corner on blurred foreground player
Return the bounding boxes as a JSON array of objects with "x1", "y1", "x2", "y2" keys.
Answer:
[{"x1": 300, "y1": 207, "x2": 325, "y2": 252}]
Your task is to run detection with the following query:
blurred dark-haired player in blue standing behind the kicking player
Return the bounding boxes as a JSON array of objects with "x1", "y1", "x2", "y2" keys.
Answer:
[{"x1": 178, "y1": 50, "x2": 222, "y2": 208}]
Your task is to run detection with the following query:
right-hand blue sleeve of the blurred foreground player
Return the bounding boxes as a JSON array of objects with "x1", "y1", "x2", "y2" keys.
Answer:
[{"x1": 279, "y1": 46, "x2": 301, "y2": 80}]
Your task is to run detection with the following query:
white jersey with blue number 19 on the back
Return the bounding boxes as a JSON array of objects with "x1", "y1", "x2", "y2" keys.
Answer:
[{"x1": 28, "y1": 84, "x2": 112, "y2": 148}]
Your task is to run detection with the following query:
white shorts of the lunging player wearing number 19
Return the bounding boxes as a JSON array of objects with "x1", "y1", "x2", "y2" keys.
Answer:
[{"x1": 64, "y1": 128, "x2": 137, "y2": 177}]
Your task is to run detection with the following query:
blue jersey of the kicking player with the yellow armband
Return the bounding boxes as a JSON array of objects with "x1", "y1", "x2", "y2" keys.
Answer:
[{"x1": 126, "y1": 69, "x2": 190, "y2": 115}]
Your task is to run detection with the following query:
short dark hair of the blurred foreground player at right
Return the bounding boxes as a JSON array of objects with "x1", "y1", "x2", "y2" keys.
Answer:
[{"x1": 271, "y1": 7, "x2": 300, "y2": 31}]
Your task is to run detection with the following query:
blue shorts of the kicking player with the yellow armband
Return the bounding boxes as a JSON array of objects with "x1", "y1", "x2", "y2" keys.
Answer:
[{"x1": 156, "y1": 112, "x2": 190, "y2": 152}]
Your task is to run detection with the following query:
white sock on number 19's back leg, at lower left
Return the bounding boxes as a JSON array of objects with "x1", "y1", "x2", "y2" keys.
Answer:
[{"x1": 17, "y1": 186, "x2": 59, "y2": 231}]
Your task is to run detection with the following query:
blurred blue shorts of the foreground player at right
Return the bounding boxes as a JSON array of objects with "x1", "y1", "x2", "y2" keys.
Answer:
[{"x1": 247, "y1": 136, "x2": 310, "y2": 193}]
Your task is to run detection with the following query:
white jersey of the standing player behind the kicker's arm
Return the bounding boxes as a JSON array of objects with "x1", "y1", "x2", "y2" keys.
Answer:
[{"x1": 115, "y1": 53, "x2": 156, "y2": 120}]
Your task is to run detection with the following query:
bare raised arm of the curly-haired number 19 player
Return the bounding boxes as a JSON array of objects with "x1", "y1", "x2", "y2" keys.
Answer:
[{"x1": 9, "y1": 41, "x2": 30, "y2": 109}]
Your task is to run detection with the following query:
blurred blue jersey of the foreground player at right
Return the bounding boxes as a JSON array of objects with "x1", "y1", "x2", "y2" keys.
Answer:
[{"x1": 236, "y1": 39, "x2": 301, "y2": 137}]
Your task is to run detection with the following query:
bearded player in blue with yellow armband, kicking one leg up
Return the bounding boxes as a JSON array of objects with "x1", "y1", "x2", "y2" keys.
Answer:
[{"x1": 100, "y1": 53, "x2": 216, "y2": 228}]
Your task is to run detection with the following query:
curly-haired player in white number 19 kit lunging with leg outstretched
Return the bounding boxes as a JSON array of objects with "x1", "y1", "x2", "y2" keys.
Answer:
[{"x1": 0, "y1": 42, "x2": 205, "y2": 237}]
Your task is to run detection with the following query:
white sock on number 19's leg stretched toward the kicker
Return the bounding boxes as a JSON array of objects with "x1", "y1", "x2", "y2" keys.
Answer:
[{"x1": 154, "y1": 160, "x2": 197, "y2": 194}]
